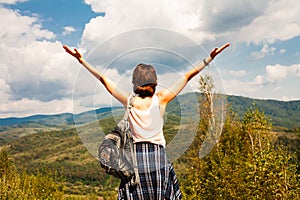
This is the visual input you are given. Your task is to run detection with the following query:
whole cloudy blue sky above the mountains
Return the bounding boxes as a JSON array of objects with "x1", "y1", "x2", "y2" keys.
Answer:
[{"x1": 0, "y1": 0, "x2": 300, "y2": 118}]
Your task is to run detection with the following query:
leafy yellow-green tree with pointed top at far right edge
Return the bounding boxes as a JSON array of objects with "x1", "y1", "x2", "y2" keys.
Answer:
[{"x1": 241, "y1": 105, "x2": 300, "y2": 199}]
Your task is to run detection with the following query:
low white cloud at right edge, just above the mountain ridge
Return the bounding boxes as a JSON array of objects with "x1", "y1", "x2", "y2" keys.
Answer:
[{"x1": 224, "y1": 64, "x2": 300, "y2": 101}]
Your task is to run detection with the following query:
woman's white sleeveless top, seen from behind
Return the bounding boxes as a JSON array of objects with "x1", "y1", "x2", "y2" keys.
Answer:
[{"x1": 129, "y1": 95, "x2": 166, "y2": 146}]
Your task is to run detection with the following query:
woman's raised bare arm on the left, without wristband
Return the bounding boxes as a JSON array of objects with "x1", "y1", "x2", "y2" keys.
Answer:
[{"x1": 63, "y1": 45, "x2": 130, "y2": 107}]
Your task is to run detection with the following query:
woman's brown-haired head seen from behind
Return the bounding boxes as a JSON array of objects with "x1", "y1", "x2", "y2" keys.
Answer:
[{"x1": 132, "y1": 63, "x2": 157, "y2": 98}]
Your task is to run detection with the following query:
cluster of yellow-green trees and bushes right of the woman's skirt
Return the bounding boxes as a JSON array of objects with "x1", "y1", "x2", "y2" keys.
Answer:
[{"x1": 182, "y1": 105, "x2": 300, "y2": 200}]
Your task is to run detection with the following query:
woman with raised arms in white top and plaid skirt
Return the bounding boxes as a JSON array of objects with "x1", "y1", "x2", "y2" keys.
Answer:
[{"x1": 63, "y1": 44, "x2": 230, "y2": 200}]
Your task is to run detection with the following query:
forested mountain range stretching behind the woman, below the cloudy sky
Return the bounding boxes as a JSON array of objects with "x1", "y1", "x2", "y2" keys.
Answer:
[{"x1": 0, "y1": 93, "x2": 300, "y2": 196}]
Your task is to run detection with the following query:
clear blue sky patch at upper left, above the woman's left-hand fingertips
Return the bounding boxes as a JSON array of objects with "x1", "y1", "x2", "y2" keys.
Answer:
[{"x1": 4, "y1": 0, "x2": 104, "y2": 45}]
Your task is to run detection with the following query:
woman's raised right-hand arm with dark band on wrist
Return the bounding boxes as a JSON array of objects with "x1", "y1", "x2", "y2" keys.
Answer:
[{"x1": 157, "y1": 43, "x2": 230, "y2": 106}]
